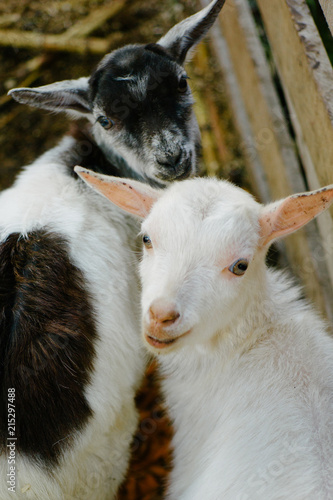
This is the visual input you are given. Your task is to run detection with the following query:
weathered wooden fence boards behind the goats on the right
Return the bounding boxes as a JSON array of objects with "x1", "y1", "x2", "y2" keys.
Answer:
[{"x1": 202, "y1": 0, "x2": 333, "y2": 320}]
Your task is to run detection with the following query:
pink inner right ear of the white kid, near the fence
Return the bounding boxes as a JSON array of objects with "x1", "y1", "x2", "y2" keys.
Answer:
[{"x1": 259, "y1": 185, "x2": 333, "y2": 246}]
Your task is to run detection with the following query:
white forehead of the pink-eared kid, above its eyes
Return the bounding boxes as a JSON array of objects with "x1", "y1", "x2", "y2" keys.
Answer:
[{"x1": 143, "y1": 179, "x2": 260, "y2": 249}]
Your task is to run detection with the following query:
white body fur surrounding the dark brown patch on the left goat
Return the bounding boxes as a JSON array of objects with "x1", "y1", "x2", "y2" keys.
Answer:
[{"x1": 0, "y1": 137, "x2": 144, "y2": 500}]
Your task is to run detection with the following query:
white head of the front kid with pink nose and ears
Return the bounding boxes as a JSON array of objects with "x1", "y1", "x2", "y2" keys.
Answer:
[{"x1": 77, "y1": 169, "x2": 333, "y2": 352}]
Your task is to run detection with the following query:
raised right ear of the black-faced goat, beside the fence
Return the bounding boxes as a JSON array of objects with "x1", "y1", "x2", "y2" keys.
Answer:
[{"x1": 157, "y1": 0, "x2": 225, "y2": 64}]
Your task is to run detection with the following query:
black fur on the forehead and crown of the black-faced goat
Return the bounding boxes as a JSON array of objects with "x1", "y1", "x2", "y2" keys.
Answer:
[{"x1": 90, "y1": 44, "x2": 191, "y2": 129}]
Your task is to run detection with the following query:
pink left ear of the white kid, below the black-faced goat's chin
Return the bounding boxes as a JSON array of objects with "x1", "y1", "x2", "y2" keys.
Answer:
[{"x1": 74, "y1": 166, "x2": 161, "y2": 219}]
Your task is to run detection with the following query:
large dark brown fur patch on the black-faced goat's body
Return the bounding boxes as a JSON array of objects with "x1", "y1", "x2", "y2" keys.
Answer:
[{"x1": 0, "y1": 231, "x2": 97, "y2": 465}]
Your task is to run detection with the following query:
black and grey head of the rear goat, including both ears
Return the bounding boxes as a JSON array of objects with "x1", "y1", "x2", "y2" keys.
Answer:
[{"x1": 9, "y1": 0, "x2": 225, "y2": 183}]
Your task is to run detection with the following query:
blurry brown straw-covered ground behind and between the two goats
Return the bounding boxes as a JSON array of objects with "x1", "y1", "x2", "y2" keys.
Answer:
[{"x1": 0, "y1": 0, "x2": 245, "y2": 500}]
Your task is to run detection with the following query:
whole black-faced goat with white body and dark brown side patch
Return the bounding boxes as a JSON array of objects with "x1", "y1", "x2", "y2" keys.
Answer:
[{"x1": 0, "y1": 0, "x2": 224, "y2": 500}]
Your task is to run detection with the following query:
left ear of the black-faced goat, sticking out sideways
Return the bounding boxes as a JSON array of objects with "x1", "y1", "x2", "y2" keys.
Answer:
[{"x1": 8, "y1": 77, "x2": 91, "y2": 116}]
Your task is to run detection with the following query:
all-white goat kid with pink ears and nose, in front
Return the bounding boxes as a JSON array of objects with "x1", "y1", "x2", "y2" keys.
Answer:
[{"x1": 76, "y1": 170, "x2": 333, "y2": 500}]
